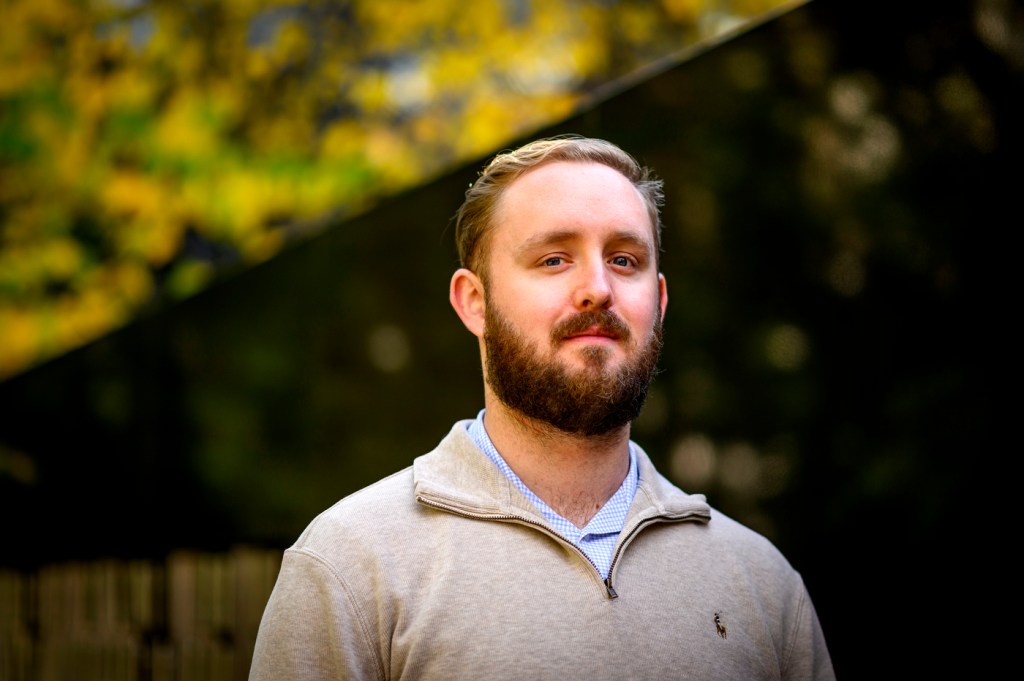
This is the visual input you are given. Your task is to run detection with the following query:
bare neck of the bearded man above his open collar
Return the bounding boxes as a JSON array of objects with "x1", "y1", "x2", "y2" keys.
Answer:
[{"x1": 483, "y1": 399, "x2": 630, "y2": 527}]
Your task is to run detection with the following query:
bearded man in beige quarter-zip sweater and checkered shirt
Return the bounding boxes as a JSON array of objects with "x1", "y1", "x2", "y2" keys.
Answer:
[{"x1": 251, "y1": 136, "x2": 834, "y2": 681}]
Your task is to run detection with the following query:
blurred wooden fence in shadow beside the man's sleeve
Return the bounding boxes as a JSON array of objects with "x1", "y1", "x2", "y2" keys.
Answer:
[{"x1": 0, "y1": 548, "x2": 282, "y2": 681}]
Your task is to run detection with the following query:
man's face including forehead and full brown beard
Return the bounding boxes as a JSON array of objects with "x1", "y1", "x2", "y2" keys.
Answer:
[{"x1": 484, "y1": 162, "x2": 668, "y2": 435}]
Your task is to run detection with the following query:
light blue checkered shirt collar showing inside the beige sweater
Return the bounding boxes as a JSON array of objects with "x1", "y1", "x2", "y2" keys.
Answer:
[{"x1": 469, "y1": 410, "x2": 637, "y2": 579}]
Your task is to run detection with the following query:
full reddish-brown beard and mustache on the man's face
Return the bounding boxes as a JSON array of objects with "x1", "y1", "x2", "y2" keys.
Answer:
[{"x1": 483, "y1": 302, "x2": 663, "y2": 436}]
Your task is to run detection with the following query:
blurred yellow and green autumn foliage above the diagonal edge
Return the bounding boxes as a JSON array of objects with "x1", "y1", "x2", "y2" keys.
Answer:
[{"x1": 0, "y1": 0, "x2": 786, "y2": 380}]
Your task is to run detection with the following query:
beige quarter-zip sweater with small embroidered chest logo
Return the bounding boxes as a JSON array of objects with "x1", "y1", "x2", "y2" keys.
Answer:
[{"x1": 250, "y1": 422, "x2": 835, "y2": 681}]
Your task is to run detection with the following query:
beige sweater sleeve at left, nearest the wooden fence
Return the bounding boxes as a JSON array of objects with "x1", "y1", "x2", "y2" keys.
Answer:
[{"x1": 249, "y1": 548, "x2": 386, "y2": 681}]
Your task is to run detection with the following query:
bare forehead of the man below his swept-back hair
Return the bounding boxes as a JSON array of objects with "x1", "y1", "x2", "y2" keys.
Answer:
[{"x1": 493, "y1": 161, "x2": 654, "y2": 248}]
